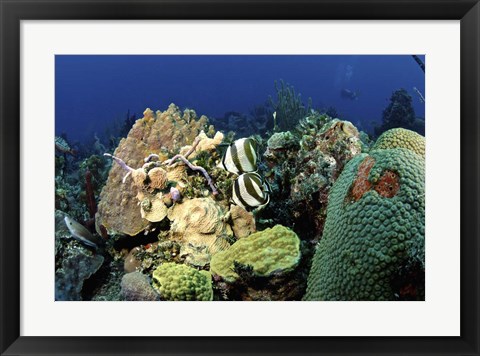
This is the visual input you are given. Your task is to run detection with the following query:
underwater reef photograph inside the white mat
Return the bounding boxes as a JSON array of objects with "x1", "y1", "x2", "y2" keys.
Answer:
[{"x1": 54, "y1": 54, "x2": 428, "y2": 302}]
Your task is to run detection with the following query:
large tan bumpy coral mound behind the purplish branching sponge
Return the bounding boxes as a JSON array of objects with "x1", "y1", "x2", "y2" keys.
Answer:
[{"x1": 97, "y1": 104, "x2": 213, "y2": 236}]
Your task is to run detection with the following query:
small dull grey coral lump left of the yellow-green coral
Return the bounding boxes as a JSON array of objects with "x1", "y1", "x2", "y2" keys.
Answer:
[{"x1": 120, "y1": 272, "x2": 160, "y2": 301}]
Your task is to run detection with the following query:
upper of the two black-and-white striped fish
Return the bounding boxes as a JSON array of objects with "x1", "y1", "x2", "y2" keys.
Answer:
[{"x1": 219, "y1": 138, "x2": 257, "y2": 174}]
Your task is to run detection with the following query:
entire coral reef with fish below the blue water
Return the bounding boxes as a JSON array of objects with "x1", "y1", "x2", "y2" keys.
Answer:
[{"x1": 56, "y1": 92, "x2": 425, "y2": 301}]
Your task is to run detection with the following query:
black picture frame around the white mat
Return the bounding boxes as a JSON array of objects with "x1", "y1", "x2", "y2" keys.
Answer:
[{"x1": 0, "y1": 0, "x2": 480, "y2": 356}]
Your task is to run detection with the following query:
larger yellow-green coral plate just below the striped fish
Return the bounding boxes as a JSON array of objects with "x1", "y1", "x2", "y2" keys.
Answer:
[{"x1": 210, "y1": 225, "x2": 300, "y2": 282}]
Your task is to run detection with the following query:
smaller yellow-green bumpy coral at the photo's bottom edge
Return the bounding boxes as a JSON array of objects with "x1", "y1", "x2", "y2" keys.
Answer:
[{"x1": 152, "y1": 263, "x2": 213, "y2": 300}]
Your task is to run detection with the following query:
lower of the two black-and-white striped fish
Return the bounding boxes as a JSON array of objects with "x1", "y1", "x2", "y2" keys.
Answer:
[{"x1": 232, "y1": 173, "x2": 271, "y2": 210}]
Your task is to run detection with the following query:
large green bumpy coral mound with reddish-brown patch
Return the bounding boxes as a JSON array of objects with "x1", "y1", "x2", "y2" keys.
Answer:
[{"x1": 304, "y1": 148, "x2": 425, "y2": 300}]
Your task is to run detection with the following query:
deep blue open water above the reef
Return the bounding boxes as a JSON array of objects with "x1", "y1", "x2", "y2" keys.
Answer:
[{"x1": 55, "y1": 55, "x2": 428, "y2": 141}]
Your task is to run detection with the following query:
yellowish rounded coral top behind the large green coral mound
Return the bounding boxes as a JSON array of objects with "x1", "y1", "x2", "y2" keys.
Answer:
[{"x1": 372, "y1": 128, "x2": 425, "y2": 158}]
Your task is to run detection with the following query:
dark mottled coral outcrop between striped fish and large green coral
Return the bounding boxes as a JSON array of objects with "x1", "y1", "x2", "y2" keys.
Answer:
[{"x1": 264, "y1": 117, "x2": 362, "y2": 239}]
